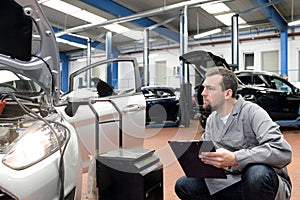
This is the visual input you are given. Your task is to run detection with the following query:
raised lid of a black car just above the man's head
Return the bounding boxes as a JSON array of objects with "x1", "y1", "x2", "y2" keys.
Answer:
[{"x1": 179, "y1": 50, "x2": 233, "y2": 74}]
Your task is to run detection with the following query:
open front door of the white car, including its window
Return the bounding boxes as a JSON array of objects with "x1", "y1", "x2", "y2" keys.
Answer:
[{"x1": 59, "y1": 58, "x2": 146, "y2": 168}]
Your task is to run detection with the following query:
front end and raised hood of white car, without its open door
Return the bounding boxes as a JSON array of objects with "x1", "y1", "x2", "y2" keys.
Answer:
[{"x1": 0, "y1": 0, "x2": 82, "y2": 199}]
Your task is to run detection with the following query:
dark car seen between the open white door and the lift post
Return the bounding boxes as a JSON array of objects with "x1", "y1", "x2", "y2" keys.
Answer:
[{"x1": 142, "y1": 86, "x2": 179, "y2": 124}]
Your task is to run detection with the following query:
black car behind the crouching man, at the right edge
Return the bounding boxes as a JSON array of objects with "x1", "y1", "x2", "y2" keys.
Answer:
[{"x1": 236, "y1": 71, "x2": 300, "y2": 121}]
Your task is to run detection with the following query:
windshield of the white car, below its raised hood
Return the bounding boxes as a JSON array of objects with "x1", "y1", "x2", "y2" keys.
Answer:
[{"x1": 0, "y1": 70, "x2": 42, "y2": 96}]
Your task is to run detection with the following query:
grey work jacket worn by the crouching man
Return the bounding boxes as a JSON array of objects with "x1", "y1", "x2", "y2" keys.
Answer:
[{"x1": 202, "y1": 96, "x2": 292, "y2": 200}]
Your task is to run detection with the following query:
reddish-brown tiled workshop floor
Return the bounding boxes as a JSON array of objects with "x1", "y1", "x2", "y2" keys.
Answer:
[{"x1": 82, "y1": 120, "x2": 300, "y2": 200}]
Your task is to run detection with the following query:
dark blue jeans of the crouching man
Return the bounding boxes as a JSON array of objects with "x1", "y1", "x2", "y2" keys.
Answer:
[{"x1": 175, "y1": 164, "x2": 279, "y2": 200}]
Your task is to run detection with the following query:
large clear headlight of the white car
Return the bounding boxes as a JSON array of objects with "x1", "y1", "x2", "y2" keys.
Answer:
[{"x1": 2, "y1": 121, "x2": 66, "y2": 170}]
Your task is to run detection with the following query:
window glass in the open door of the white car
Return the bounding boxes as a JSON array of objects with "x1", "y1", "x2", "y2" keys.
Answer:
[{"x1": 71, "y1": 61, "x2": 136, "y2": 96}]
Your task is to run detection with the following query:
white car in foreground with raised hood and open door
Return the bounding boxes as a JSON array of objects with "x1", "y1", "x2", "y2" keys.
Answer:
[{"x1": 0, "y1": 0, "x2": 145, "y2": 200}]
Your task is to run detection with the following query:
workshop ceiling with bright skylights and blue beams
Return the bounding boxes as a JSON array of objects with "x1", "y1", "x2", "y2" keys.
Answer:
[{"x1": 40, "y1": 0, "x2": 300, "y2": 54}]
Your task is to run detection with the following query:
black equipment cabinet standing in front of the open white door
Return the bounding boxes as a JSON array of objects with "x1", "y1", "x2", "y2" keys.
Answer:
[{"x1": 96, "y1": 148, "x2": 163, "y2": 200}]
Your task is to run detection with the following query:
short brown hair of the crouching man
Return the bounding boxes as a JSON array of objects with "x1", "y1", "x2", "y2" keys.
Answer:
[{"x1": 205, "y1": 67, "x2": 238, "y2": 98}]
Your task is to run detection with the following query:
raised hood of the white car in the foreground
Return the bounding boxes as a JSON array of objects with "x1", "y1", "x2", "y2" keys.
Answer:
[{"x1": 0, "y1": 0, "x2": 60, "y2": 102}]
